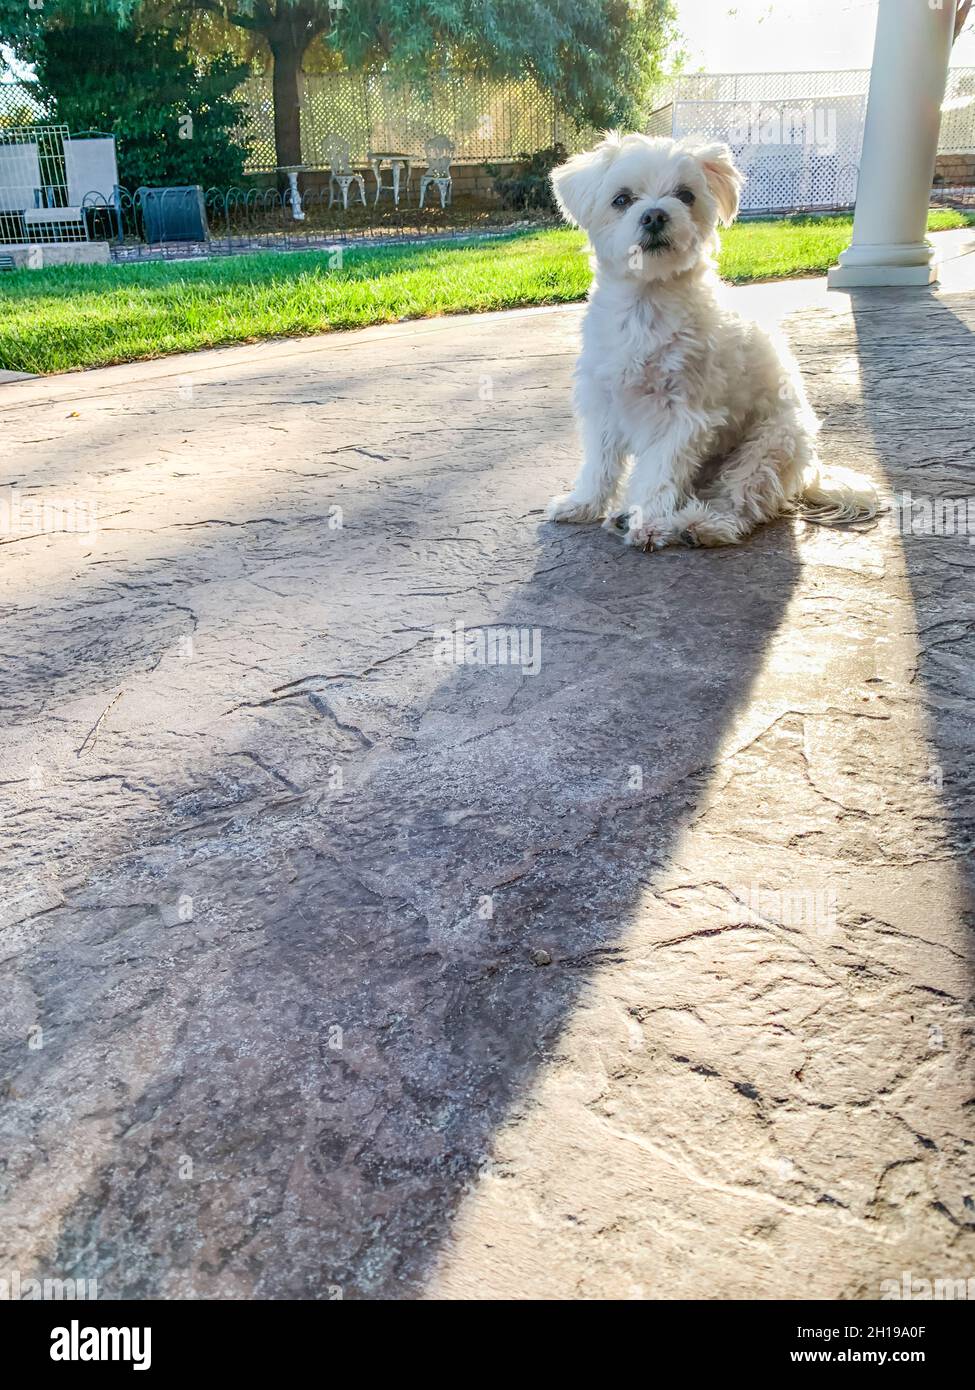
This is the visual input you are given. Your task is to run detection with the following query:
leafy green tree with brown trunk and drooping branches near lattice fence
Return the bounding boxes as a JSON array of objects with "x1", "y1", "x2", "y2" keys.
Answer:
[{"x1": 0, "y1": 0, "x2": 675, "y2": 164}]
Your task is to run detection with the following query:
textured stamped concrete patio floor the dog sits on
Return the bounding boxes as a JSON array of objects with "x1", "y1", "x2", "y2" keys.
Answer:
[{"x1": 0, "y1": 230, "x2": 975, "y2": 1298}]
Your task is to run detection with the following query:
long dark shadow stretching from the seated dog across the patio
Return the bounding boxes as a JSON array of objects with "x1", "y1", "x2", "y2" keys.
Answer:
[{"x1": 0, "y1": 442, "x2": 797, "y2": 1297}]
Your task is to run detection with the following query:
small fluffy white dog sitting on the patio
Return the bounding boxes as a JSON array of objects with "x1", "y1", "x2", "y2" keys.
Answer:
[{"x1": 548, "y1": 133, "x2": 878, "y2": 550}]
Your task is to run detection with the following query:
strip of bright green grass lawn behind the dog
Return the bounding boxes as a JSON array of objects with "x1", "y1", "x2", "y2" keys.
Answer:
[{"x1": 0, "y1": 210, "x2": 975, "y2": 373}]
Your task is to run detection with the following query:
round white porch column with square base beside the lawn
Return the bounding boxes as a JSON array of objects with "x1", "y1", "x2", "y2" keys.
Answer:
[{"x1": 829, "y1": 0, "x2": 956, "y2": 289}]
